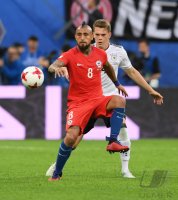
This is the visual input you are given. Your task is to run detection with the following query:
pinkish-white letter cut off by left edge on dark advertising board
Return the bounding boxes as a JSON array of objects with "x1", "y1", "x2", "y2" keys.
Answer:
[{"x1": 0, "y1": 86, "x2": 26, "y2": 140}]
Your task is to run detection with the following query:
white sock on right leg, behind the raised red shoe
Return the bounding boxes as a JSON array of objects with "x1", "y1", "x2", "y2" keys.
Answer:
[{"x1": 118, "y1": 127, "x2": 131, "y2": 172}]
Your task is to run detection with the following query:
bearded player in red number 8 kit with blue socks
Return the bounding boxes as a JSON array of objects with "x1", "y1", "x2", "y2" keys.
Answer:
[{"x1": 49, "y1": 24, "x2": 135, "y2": 181}]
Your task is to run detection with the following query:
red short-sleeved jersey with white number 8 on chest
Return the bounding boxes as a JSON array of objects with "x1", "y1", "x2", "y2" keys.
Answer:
[{"x1": 58, "y1": 46, "x2": 107, "y2": 103}]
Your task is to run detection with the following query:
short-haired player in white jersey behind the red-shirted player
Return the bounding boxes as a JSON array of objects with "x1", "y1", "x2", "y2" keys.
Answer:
[{"x1": 46, "y1": 19, "x2": 163, "y2": 178}]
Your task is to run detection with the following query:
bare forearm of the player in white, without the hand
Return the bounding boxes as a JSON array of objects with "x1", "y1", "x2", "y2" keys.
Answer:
[{"x1": 125, "y1": 68, "x2": 153, "y2": 93}]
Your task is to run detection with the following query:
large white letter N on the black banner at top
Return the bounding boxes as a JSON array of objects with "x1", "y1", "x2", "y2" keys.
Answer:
[{"x1": 114, "y1": 0, "x2": 148, "y2": 37}]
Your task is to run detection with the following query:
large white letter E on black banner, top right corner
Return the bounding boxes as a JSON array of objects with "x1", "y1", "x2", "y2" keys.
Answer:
[{"x1": 146, "y1": 1, "x2": 177, "y2": 39}]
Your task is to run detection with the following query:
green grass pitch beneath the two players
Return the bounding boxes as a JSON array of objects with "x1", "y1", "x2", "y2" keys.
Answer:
[{"x1": 0, "y1": 139, "x2": 178, "y2": 200}]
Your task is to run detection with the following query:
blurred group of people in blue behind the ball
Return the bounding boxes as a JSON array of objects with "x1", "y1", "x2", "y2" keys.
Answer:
[{"x1": 0, "y1": 36, "x2": 70, "y2": 87}]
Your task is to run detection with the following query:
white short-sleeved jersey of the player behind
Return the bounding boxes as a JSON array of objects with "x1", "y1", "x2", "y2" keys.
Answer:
[{"x1": 101, "y1": 44, "x2": 132, "y2": 96}]
